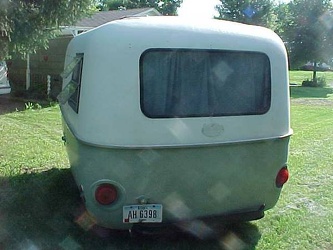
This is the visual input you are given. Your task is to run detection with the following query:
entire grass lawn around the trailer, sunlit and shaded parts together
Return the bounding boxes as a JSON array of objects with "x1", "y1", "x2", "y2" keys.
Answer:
[{"x1": 0, "y1": 72, "x2": 333, "y2": 249}]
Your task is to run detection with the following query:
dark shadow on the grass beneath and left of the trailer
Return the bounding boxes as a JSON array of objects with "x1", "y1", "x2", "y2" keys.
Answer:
[{"x1": 0, "y1": 169, "x2": 261, "y2": 250}]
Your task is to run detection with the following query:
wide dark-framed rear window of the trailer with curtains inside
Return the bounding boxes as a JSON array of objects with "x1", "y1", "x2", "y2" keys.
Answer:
[{"x1": 140, "y1": 49, "x2": 271, "y2": 118}]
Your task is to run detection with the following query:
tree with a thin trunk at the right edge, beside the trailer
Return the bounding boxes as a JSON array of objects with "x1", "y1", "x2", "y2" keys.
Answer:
[{"x1": 281, "y1": 0, "x2": 333, "y2": 82}]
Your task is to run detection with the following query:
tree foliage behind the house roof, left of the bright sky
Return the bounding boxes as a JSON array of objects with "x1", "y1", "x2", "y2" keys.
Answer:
[{"x1": 101, "y1": 0, "x2": 183, "y2": 16}]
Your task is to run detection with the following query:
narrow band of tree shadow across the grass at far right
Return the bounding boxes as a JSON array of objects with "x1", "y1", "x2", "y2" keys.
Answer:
[{"x1": 290, "y1": 86, "x2": 333, "y2": 98}]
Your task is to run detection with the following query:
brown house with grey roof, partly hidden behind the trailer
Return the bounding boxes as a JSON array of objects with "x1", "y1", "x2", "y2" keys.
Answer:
[{"x1": 7, "y1": 8, "x2": 161, "y2": 98}]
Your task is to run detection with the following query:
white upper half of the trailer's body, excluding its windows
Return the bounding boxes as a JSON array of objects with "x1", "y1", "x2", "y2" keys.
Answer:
[{"x1": 62, "y1": 17, "x2": 290, "y2": 147}]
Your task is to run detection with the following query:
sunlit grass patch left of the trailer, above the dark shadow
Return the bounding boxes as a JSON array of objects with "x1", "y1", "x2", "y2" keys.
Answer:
[{"x1": 0, "y1": 107, "x2": 68, "y2": 176}]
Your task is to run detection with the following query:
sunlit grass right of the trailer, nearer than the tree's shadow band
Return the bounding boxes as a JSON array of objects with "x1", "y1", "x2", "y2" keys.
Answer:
[{"x1": 255, "y1": 103, "x2": 333, "y2": 249}]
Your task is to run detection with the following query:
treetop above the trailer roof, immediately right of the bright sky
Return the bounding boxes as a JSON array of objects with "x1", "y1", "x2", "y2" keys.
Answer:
[{"x1": 216, "y1": 0, "x2": 274, "y2": 27}]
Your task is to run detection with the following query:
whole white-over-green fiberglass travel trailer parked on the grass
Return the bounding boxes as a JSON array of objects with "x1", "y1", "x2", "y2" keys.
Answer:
[{"x1": 59, "y1": 17, "x2": 291, "y2": 229}]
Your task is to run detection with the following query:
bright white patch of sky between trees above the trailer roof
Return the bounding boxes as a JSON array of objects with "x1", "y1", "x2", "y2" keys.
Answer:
[{"x1": 178, "y1": 0, "x2": 220, "y2": 18}]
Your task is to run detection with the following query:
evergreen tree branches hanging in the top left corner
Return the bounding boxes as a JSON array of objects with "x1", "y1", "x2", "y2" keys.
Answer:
[{"x1": 0, "y1": 0, "x2": 96, "y2": 60}]
